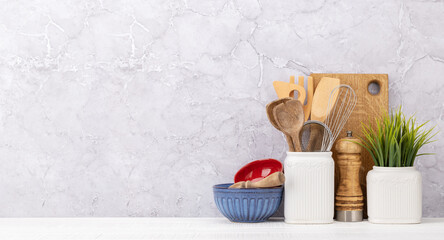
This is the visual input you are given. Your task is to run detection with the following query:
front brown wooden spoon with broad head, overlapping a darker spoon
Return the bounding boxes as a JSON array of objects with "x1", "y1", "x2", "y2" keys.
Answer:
[{"x1": 273, "y1": 99, "x2": 304, "y2": 152}]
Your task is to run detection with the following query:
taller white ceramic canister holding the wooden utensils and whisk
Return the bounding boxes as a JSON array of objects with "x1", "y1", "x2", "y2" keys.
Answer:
[{"x1": 284, "y1": 152, "x2": 335, "y2": 223}]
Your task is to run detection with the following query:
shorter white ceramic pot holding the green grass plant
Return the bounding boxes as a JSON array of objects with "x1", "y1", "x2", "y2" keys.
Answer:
[{"x1": 367, "y1": 166, "x2": 422, "y2": 223}]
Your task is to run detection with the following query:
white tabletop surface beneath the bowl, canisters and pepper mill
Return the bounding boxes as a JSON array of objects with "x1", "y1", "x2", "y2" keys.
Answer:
[{"x1": 0, "y1": 218, "x2": 444, "y2": 240}]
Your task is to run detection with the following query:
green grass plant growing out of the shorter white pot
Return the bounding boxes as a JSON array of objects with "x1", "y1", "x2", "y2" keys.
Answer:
[{"x1": 357, "y1": 108, "x2": 437, "y2": 167}]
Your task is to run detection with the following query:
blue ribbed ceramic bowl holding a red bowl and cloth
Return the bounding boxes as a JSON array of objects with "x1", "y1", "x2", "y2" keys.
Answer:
[{"x1": 213, "y1": 183, "x2": 284, "y2": 222}]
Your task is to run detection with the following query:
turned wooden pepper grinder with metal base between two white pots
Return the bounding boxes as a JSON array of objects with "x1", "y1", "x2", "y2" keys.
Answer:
[{"x1": 335, "y1": 131, "x2": 364, "y2": 222}]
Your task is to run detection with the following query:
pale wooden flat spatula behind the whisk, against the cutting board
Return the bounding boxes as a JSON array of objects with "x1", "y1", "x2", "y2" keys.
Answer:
[{"x1": 311, "y1": 77, "x2": 341, "y2": 122}]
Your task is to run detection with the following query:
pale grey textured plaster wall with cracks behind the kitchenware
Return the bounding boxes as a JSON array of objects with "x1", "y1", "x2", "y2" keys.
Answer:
[{"x1": 0, "y1": 0, "x2": 444, "y2": 217}]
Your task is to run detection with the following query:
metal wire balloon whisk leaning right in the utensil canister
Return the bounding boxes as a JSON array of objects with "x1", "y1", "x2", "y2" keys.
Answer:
[{"x1": 322, "y1": 84, "x2": 357, "y2": 151}]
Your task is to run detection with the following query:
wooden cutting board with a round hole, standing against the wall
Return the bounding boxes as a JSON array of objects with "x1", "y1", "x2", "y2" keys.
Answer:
[{"x1": 310, "y1": 73, "x2": 389, "y2": 216}]
